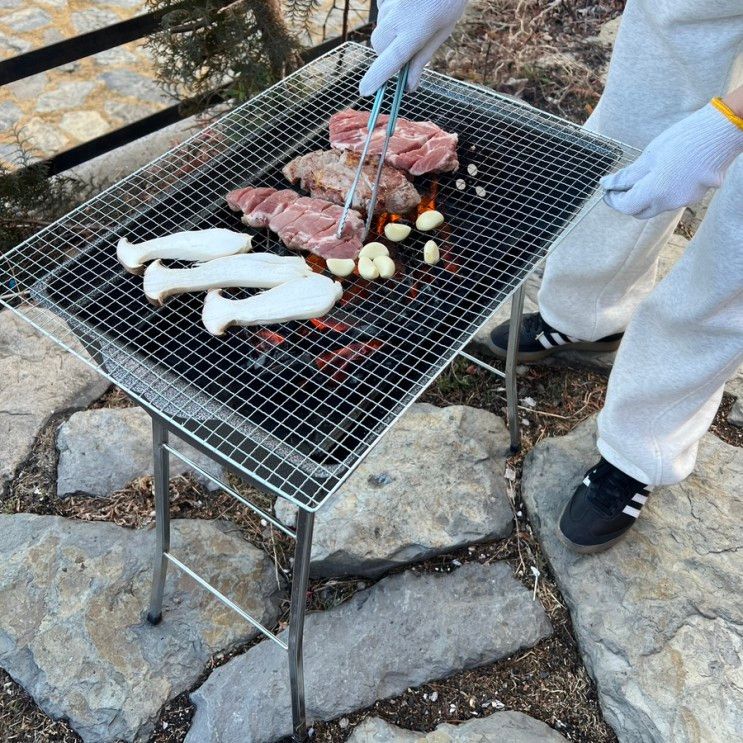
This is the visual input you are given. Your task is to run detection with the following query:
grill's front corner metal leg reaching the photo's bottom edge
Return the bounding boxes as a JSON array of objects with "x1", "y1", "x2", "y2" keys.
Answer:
[{"x1": 289, "y1": 509, "x2": 315, "y2": 743}]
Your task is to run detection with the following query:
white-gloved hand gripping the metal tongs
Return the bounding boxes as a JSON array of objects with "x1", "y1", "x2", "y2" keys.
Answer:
[{"x1": 359, "y1": 0, "x2": 467, "y2": 95}]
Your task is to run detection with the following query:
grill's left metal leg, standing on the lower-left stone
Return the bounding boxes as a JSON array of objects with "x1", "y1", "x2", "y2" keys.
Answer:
[{"x1": 147, "y1": 418, "x2": 170, "y2": 624}]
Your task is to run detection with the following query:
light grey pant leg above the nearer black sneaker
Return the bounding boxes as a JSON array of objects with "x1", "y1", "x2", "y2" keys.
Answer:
[{"x1": 598, "y1": 155, "x2": 743, "y2": 485}]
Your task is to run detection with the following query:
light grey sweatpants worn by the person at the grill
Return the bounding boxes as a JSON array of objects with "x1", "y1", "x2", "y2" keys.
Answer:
[{"x1": 539, "y1": 0, "x2": 743, "y2": 485}]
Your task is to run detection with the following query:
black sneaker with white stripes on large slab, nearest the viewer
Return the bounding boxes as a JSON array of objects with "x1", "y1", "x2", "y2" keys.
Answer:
[{"x1": 558, "y1": 457, "x2": 652, "y2": 552}]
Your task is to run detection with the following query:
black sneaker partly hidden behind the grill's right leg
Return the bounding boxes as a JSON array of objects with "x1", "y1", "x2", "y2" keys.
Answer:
[{"x1": 484, "y1": 312, "x2": 623, "y2": 362}]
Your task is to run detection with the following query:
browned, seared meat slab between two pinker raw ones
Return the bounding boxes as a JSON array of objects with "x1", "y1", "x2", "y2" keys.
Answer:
[{"x1": 283, "y1": 150, "x2": 421, "y2": 214}]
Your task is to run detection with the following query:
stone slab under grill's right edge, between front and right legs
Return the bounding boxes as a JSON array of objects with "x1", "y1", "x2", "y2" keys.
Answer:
[{"x1": 276, "y1": 404, "x2": 513, "y2": 575}]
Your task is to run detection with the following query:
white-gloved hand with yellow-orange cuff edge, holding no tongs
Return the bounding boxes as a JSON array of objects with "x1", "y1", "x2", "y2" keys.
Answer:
[{"x1": 601, "y1": 98, "x2": 743, "y2": 219}]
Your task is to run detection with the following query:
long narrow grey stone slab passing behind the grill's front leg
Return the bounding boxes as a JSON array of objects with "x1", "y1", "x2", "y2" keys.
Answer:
[{"x1": 186, "y1": 563, "x2": 552, "y2": 743}]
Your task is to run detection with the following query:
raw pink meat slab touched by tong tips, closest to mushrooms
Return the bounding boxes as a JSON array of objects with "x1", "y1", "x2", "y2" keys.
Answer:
[{"x1": 226, "y1": 186, "x2": 364, "y2": 259}]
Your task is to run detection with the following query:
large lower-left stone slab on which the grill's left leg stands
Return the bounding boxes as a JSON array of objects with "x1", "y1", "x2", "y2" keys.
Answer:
[{"x1": 0, "y1": 514, "x2": 279, "y2": 743}]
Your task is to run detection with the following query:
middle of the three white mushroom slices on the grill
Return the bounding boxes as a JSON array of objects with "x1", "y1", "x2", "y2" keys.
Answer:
[{"x1": 144, "y1": 253, "x2": 312, "y2": 305}]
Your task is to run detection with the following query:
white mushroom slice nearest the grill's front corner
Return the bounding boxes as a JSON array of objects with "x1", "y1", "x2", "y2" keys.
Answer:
[{"x1": 202, "y1": 274, "x2": 343, "y2": 335}]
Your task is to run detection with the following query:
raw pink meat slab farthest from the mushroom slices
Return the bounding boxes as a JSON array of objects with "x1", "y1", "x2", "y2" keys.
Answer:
[{"x1": 329, "y1": 108, "x2": 459, "y2": 175}]
